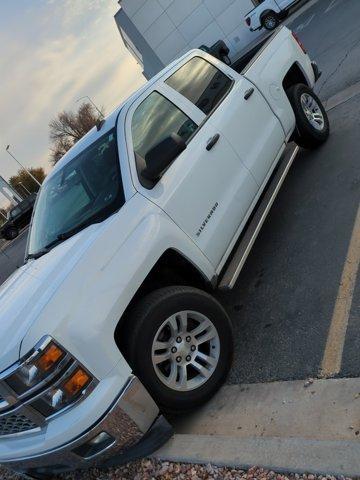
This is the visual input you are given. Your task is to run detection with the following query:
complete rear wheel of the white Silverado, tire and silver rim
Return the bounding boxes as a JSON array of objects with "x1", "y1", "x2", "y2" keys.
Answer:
[{"x1": 287, "y1": 84, "x2": 330, "y2": 149}]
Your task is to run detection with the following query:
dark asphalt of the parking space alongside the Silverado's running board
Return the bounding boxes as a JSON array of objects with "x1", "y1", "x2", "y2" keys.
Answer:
[{"x1": 221, "y1": 97, "x2": 360, "y2": 383}]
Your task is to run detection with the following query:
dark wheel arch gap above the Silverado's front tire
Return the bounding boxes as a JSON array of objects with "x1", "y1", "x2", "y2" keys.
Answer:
[{"x1": 114, "y1": 248, "x2": 216, "y2": 359}]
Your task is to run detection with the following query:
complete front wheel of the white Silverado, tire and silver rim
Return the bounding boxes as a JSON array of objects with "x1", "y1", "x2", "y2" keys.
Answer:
[{"x1": 128, "y1": 286, "x2": 233, "y2": 413}]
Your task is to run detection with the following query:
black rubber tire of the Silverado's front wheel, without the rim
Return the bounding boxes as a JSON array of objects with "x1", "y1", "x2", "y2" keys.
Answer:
[{"x1": 127, "y1": 286, "x2": 233, "y2": 414}]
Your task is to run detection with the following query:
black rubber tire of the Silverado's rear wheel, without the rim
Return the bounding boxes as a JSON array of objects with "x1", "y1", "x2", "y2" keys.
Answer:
[{"x1": 287, "y1": 83, "x2": 330, "y2": 149}]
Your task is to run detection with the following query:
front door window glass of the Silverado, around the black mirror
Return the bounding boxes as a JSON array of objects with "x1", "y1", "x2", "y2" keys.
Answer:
[{"x1": 131, "y1": 92, "x2": 197, "y2": 158}]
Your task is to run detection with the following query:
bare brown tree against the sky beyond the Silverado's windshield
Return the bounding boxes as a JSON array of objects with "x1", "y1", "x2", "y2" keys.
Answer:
[{"x1": 49, "y1": 102, "x2": 104, "y2": 165}]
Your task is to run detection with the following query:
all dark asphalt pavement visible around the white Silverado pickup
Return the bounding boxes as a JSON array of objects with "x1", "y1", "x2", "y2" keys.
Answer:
[{"x1": 0, "y1": 0, "x2": 360, "y2": 390}]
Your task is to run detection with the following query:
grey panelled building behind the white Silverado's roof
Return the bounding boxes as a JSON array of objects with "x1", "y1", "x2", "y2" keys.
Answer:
[{"x1": 115, "y1": 0, "x2": 260, "y2": 79}]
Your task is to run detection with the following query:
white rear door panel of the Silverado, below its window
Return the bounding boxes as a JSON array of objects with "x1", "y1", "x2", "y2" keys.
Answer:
[{"x1": 209, "y1": 78, "x2": 285, "y2": 185}]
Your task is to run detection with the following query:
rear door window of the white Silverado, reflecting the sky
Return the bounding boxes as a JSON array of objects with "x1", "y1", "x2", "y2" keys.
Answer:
[{"x1": 165, "y1": 57, "x2": 232, "y2": 115}]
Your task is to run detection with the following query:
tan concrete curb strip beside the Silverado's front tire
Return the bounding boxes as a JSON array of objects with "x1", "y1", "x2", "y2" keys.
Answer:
[{"x1": 154, "y1": 378, "x2": 360, "y2": 477}]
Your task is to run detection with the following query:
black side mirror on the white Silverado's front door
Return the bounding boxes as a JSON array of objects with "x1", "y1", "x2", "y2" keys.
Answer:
[{"x1": 142, "y1": 133, "x2": 186, "y2": 182}]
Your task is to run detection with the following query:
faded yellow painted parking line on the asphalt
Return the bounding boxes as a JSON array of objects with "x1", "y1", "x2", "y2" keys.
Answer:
[{"x1": 320, "y1": 207, "x2": 360, "y2": 377}]
